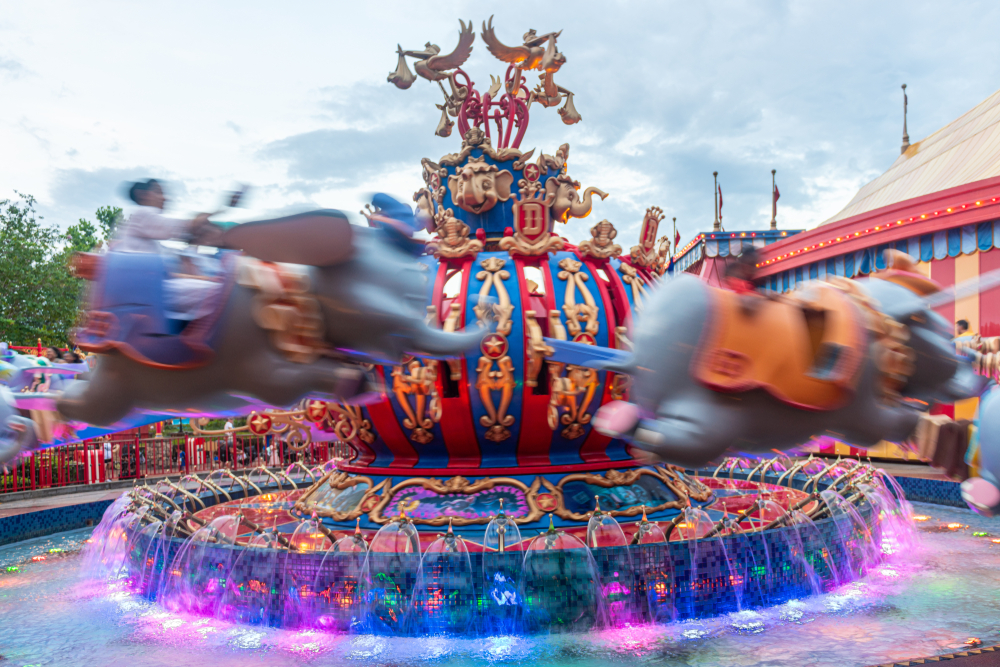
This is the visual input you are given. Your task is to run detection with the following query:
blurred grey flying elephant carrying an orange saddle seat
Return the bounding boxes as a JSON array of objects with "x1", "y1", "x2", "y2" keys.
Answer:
[{"x1": 546, "y1": 251, "x2": 983, "y2": 467}]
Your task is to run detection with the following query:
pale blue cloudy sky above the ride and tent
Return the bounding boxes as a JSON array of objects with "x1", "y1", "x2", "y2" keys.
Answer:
[{"x1": 0, "y1": 0, "x2": 1000, "y2": 251}]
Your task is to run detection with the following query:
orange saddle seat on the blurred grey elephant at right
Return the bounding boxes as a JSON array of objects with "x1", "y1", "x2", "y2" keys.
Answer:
[{"x1": 692, "y1": 283, "x2": 867, "y2": 410}]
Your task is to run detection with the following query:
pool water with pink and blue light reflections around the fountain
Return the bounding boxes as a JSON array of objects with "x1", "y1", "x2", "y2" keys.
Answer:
[{"x1": 0, "y1": 504, "x2": 1000, "y2": 667}]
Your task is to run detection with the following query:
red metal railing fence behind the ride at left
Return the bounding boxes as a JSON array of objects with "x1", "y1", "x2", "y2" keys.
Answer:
[{"x1": 0, "y1": 436, "x2": 353, "y2": 493}]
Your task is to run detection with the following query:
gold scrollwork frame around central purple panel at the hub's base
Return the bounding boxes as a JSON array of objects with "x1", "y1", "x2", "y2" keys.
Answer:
[{"x1": 359, "y1": 476, "x2": 552, "y2": 526}]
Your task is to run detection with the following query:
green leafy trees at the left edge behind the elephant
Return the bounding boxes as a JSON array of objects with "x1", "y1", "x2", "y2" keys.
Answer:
[{"x1": 0, "y1": 193, "x2": 121, "y2": 346}]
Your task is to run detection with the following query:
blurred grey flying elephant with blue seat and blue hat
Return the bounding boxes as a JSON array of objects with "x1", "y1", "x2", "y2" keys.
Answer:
[{"x1": 57, "y1": 195, "x2": 482, "y2": 425}]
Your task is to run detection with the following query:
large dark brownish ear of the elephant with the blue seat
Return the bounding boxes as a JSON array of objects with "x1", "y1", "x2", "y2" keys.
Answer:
[{"x1": 213, "y1": 209, "x2": 354, "y2": 266}]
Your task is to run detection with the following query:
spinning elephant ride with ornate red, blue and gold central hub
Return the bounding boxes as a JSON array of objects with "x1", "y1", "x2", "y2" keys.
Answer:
[{"x1": 7, "y1": 14, "x2": 1000, "y2": 632}]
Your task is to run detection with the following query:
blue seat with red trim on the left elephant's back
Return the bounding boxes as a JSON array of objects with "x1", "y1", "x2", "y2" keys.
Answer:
[{"x1": 76, "y1": 252, "x2": 230, "y2": 368}]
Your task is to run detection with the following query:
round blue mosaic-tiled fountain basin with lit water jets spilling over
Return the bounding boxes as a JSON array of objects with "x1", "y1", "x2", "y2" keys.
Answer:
[{"x1": 103, "y1": 462, "x2": 906, "y2": 635}]
